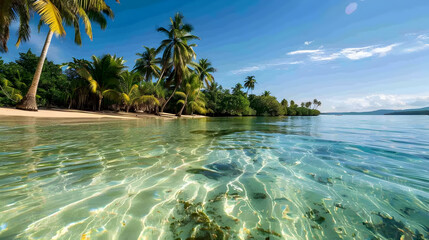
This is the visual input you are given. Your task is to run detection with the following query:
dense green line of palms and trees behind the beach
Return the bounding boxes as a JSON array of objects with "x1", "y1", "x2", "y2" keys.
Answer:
[{"x1": 0, "y1": 13, "x2": 321, "y2": 116}]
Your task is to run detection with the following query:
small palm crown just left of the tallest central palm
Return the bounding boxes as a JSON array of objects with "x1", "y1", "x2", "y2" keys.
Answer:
[{"x1": 134, "y1": 46, "x2": 161, "y2": 82}]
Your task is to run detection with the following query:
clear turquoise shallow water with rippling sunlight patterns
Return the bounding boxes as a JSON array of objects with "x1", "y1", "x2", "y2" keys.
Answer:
[{"x1": 0, "y1": 116, "x2": 429, "y2": 239}]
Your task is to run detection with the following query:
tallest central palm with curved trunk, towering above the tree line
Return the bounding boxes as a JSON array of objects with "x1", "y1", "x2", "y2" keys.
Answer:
[{"x1": 158, "y1": 13, "x2": 199, "y2": 112}]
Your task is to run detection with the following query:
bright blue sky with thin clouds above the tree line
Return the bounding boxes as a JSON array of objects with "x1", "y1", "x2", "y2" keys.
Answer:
[{"x1": 1, "y1": 0, "x2": 429, "y2": 112}]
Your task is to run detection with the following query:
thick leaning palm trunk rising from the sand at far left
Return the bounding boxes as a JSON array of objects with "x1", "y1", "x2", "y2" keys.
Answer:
[{"x1": 16, "y1": 30, "x2": 54, "y2": 111}]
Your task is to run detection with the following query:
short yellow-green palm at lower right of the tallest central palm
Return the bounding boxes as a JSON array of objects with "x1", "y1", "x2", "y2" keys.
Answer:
[{"x1": 175, "y1": 73, "x2": 205, "y2": 117}]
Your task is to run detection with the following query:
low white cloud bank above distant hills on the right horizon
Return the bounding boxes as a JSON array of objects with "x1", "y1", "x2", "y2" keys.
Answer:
[{"x1": 325, "y1": 94, "x2": 429, "y2": 112}]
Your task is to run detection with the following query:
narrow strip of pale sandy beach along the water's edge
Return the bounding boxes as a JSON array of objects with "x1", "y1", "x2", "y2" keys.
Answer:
[{"x1": 0, "y1": 107, "x2": 206, "y2": 120}]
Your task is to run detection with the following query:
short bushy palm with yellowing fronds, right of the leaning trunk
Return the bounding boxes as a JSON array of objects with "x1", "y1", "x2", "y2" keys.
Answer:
[{"x1": 77, "y1": 54, "x2": 125, "y2": 111}]
